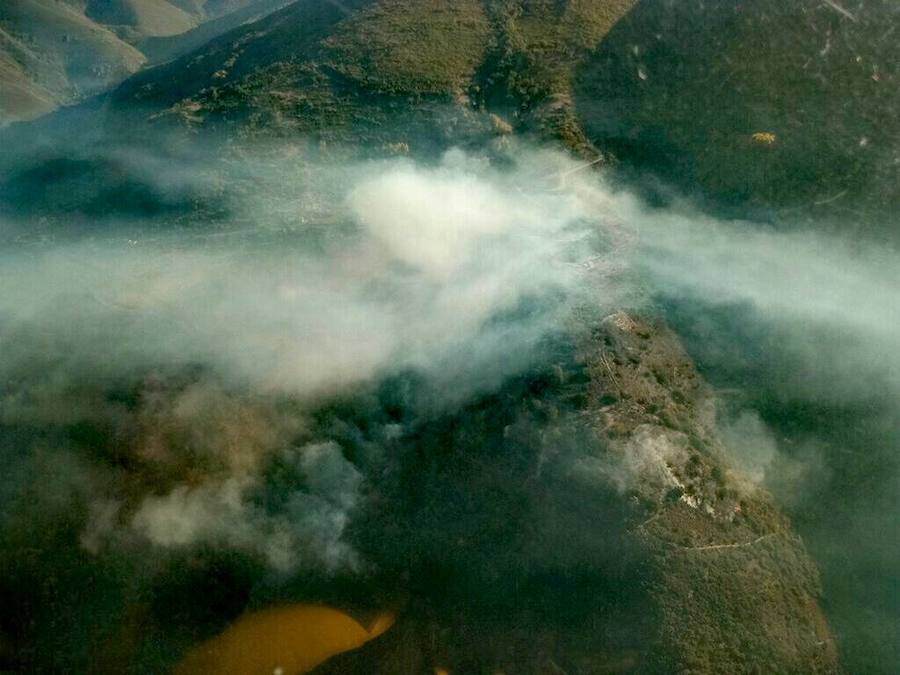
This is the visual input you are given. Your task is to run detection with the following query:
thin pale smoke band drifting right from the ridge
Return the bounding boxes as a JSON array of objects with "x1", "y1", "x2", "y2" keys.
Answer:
[{"x1": 631, "y1": 198, "x2": 900, "y2": 388}]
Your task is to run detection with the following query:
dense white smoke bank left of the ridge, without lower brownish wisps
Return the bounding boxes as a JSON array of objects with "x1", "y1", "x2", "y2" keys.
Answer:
[{"x1": 0, "y1": 149, "x2": 616, "y2": 396}]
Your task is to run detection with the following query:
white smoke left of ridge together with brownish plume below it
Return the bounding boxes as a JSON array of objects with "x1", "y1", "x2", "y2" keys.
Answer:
[{"x1": 0, "y1": 145, "x2": 620, "y2": 573}]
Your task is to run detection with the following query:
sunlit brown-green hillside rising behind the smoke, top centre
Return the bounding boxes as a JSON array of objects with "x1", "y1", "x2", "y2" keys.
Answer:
[{"x1": 111, "y1": 0, "x2": 631, "y2": 150}]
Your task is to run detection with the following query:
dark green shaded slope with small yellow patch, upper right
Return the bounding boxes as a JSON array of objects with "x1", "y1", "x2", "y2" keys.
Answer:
[{"x1": 578, "y1": 0, "x2": 900, "y2": 236}]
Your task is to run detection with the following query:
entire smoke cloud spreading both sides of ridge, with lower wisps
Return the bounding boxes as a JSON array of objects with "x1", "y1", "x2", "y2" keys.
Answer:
[{"x1": 7, "y1": 140, "x2": 900, "y2": 569}]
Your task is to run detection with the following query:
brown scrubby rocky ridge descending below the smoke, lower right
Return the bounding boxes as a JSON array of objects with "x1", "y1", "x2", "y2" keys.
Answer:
[{"x1": 585, "y1": 312, "x2": 840, "y2": 673}]
